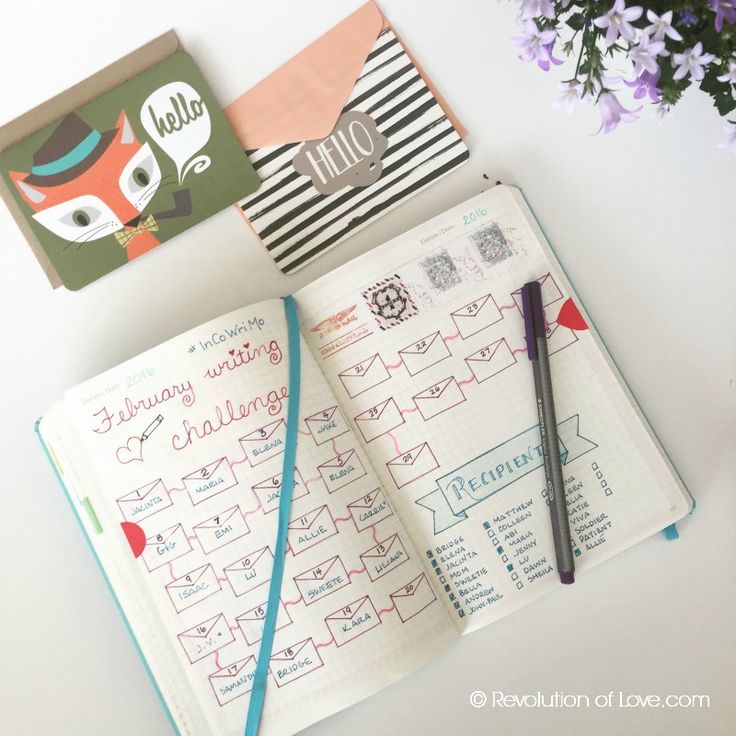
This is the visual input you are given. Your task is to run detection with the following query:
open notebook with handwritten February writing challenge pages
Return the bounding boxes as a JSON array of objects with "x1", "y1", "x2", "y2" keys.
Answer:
[{"x1": 39, "y1": 186, "x2": 692, "y2": 736}]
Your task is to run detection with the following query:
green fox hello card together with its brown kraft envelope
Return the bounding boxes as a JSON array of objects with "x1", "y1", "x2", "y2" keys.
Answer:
[{"x1": 0, "y1": 31, "x2": 260, "y2": 289}]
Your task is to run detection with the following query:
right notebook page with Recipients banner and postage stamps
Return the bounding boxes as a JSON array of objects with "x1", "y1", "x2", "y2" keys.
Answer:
[{"x1": 297, "y1": 187, "x2": 690, "y2": 630}]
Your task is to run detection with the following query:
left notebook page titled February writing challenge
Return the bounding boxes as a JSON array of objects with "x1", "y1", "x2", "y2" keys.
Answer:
[{"x1": 43, "y1": 300, "x2": 457, "y2": 736}]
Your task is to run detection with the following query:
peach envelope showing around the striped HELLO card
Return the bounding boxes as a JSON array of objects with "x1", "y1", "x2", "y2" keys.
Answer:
[{"x1": 225, "y1": 2, "x2": 465, "y2": 150}]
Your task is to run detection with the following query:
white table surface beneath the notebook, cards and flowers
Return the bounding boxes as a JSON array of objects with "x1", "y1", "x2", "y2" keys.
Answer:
[{"x1": 0, "y1": 0, "x2": 736, "y2": 736}]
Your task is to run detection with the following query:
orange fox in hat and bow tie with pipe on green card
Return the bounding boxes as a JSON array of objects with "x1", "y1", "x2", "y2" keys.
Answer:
[{"x1": 9, "y1": 111, "x2": 192, "y2": 261}]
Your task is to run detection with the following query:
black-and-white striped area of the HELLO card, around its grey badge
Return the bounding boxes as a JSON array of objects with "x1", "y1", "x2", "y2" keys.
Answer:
[{"x1": 239, "y1": 29, "x2": 468, "y2": 273}]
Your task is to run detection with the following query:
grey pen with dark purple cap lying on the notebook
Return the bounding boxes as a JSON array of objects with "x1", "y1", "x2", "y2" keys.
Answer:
[{"x1": 521, "y1": 281, "x2": 575, "y2": 585}]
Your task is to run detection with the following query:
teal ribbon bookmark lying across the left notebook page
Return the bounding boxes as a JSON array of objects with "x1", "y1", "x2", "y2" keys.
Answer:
[{"x1": 245, "y1": 296, "x2": 302, "y2": 736}]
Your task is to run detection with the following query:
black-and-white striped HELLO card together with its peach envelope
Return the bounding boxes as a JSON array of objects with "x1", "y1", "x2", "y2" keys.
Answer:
[{"x1": 225, "y1": 2, "x2": 468, "y2": 273}]
